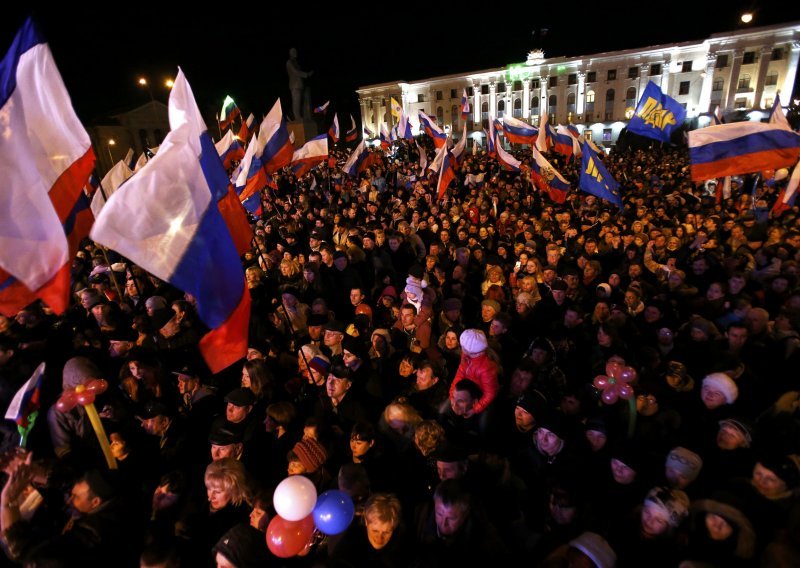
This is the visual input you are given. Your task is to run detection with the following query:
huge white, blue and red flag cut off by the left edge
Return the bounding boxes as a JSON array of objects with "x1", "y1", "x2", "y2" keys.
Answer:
[{"x1": 0, "y1": 20, "x2": 94, "y2": 316}]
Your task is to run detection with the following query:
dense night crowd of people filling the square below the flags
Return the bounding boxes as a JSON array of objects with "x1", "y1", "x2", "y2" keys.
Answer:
[{"x1": 0, "y1": 131, "x2": 800, "y2": 568}]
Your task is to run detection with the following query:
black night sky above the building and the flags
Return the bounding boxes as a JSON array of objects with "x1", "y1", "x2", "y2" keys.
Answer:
[{"x1": 0, "y1": 0, "x2": 800, "y2": 124}]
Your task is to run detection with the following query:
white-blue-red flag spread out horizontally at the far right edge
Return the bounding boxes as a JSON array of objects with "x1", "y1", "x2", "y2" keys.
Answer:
[{"x1": 689, "y1": 121, "x2": 800, "y2": 181}]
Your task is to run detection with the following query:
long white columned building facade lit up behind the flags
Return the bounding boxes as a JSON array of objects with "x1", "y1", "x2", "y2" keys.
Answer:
[{"x1": 356, "y1": 22, "x2": 800, "y2": 143}]
